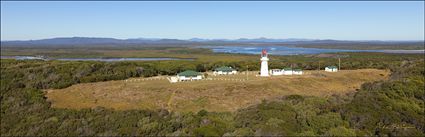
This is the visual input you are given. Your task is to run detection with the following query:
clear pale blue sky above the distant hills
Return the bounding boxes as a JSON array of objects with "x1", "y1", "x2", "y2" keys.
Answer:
[{"x1": 1, "y1": 1, "x2": 425, "y2": 41}]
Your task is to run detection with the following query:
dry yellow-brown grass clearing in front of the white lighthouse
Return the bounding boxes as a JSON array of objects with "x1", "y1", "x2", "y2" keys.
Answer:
[{"x1": 46, "y1": 69, "x2": 389, "y2": 112}]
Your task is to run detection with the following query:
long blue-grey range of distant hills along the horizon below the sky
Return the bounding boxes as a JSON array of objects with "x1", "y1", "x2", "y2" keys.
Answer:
[{"x1": 1, "y1": 37, "x2": 424, "y2": 49}]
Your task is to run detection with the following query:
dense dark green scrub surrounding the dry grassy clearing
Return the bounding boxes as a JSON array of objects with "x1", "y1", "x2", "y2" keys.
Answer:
[{"x1": 0, "y1": 53, "x2": 425, "y2": 136}]
